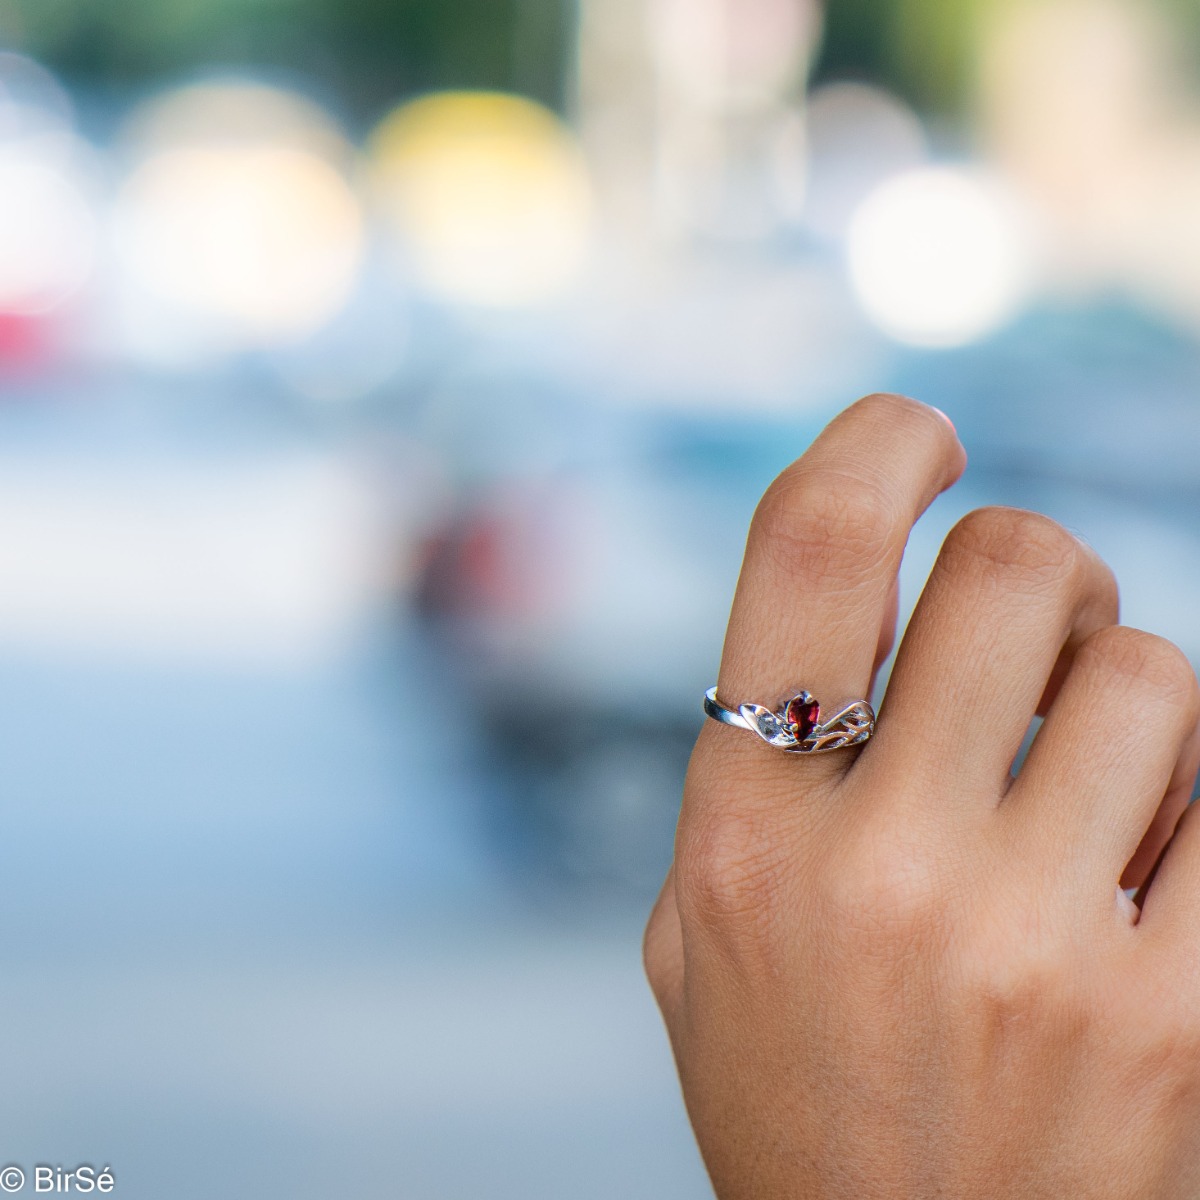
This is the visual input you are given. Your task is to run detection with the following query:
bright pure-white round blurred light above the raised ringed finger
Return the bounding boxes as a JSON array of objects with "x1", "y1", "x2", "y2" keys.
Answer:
[{"x1": 847, "y1": 167, "x2": 1032, "y2": 346}]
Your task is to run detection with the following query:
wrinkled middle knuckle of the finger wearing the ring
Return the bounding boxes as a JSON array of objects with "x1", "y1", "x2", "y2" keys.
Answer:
[{"x1": 751, "y1": 463, "x2": 896, "y2": 583}]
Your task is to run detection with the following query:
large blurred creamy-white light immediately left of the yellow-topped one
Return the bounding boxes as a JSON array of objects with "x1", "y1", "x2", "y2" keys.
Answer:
[{"x1": 116, "y1": 85, "x2": 364, "y2": 348}]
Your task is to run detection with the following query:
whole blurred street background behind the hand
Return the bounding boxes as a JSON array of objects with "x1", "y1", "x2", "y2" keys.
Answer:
[{"x1": 0, "y1": 0, "x2": 1200, "y2": 1200}]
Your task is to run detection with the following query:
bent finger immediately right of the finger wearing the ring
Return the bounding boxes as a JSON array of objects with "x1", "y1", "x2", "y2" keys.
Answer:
[{"x1": 862, "y1": 508, "x2": 1117, "y2": 800}]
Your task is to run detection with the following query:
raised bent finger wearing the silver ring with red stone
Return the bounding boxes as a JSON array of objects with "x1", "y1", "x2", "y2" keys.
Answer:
[{"x1": 702, "y1": 395, "x2": 965, "y2": 790}]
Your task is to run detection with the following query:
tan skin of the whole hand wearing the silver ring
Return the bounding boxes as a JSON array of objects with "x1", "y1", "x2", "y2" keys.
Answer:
[{"x1": 646, "y1": 395, "x2": 1200, "y2": 1200}]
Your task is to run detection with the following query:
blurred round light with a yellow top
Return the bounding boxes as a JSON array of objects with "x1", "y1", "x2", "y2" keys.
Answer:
[{"x1": 372, "y1": 92, "x2": 592, "y2": 308}]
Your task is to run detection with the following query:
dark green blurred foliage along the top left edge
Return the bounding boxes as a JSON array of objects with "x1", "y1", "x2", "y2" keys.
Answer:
[{"x1": 0, "y1": 0, "x2": 574, "y2": 113}]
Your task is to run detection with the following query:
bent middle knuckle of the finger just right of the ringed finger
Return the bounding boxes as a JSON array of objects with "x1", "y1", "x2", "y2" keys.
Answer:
[{"x1": 943, "y1": 506, "x2": 1086, "y2": 590}]
